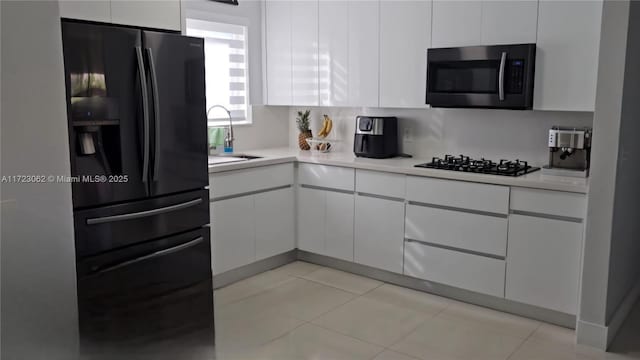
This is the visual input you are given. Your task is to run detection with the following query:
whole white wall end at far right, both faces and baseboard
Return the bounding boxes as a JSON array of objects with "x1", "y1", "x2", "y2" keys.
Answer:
[{"x1": 578, "y1": 0, "x2": 640, "y2": 348}]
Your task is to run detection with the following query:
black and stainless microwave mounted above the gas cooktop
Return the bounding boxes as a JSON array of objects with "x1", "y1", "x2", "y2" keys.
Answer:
[{"x1": 426, "y1": 44, "x2": 536, "y2": 110}]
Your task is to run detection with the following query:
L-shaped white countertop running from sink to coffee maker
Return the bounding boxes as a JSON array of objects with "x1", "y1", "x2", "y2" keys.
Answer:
[{"x1": 209, "y1": 148, "x2": 589, "y2": 194}]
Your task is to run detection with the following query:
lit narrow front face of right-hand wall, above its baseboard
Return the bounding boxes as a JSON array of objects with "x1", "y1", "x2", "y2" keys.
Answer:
[{"x1": 578, "y1": 1, "x2": 629, "y2": 334}]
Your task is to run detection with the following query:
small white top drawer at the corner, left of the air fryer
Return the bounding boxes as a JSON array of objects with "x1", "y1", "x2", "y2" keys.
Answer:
[{"x1": 298, "y1": 164, "x2": 355, "y2": 191}]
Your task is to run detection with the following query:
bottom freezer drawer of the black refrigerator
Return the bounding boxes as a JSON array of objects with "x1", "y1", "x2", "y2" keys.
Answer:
[{"x1": 77, "y1": 227, "x2": 214, "y2": 355}]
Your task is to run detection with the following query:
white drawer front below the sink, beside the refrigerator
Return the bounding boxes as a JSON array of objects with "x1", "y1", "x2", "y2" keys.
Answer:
[{"x1": 209, "y1": 163, "x2": 293, "y2": 199}]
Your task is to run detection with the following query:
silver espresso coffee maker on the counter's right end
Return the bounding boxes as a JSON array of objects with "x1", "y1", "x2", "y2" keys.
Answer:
[{"x1": 542, "y1": 126, "x2": 592, "y2": 177}]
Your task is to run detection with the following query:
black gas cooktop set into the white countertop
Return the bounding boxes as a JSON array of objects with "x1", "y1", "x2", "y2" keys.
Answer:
[{"x1": 415, "y1": 155, "x2": 540, "y2": 176}]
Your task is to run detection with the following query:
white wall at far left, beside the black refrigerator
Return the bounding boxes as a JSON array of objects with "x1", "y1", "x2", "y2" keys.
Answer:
[{"x1": 0, "y1": 1, "x2": 78, "y2": 360}]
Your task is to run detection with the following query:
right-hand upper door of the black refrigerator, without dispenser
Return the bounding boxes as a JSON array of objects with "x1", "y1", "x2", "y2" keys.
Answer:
[{"x1": 142, "y1": 31, "x2": 208, "y2": 195}]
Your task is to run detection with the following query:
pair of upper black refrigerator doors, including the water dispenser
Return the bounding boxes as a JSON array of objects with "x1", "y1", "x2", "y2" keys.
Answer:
[{"x1": 62, "y1": 20, "x2": 208, "y2": 208}]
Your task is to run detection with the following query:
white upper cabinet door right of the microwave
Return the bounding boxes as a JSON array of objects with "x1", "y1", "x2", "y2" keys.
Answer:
[{"x1": 533, "y1": 0, "x2": 602, "y2": 111}]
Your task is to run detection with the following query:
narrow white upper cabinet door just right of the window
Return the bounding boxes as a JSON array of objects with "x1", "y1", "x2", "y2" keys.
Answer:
[{"x1": 265, "y1": 0, "x2": 293, "y2": 105}]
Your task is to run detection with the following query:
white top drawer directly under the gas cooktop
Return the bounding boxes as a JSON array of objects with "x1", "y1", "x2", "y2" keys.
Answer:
[{"x1": 407, "y1": 176, "x2": 509, "y2": 214}]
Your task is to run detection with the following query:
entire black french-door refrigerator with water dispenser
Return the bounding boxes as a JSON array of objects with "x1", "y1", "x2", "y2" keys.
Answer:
[{"x1": 62, "y1": 19, "x2": 214, "y2": 359}]
